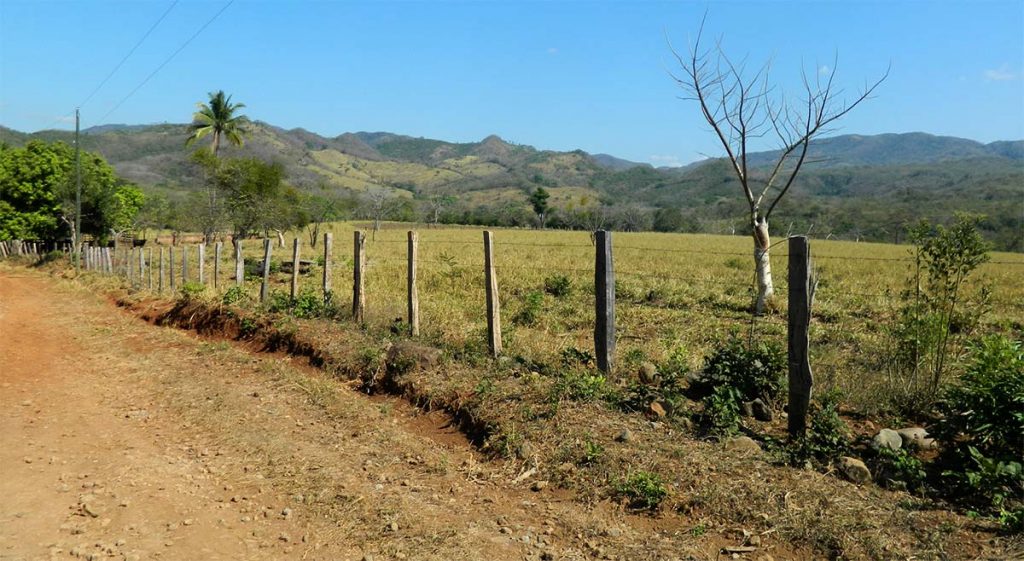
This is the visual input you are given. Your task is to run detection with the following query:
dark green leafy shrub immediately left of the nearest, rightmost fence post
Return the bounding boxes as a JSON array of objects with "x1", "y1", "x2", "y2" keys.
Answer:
[{"x1": 701, "y1": 337, "x2": 785, "y2": 401}]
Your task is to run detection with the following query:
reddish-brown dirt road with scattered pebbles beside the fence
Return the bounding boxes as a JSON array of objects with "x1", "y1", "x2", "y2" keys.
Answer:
[{"x1": 0, "y1": 268, "x2": 737, "y2": 561}]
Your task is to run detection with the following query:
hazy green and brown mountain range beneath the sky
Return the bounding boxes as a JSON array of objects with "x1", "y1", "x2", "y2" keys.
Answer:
[{"x1": 0, "y1": 122, "x2": 1024, "y2": 251}]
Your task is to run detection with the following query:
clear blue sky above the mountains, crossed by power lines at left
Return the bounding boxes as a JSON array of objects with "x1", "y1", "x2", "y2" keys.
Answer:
[{"x1": 0, "y1": 0, "x2": 1024, "y2": 165}]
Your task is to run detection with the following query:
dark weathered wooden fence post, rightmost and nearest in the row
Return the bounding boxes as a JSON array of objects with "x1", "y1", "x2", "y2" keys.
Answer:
[{"x1": 787, "y1": 235, "x2": 814, "y2": 438}]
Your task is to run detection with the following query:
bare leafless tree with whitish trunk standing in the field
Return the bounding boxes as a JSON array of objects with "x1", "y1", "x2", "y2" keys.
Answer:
[{"x1": 670, "y1": 16, "x2": 889, "y2": 313}]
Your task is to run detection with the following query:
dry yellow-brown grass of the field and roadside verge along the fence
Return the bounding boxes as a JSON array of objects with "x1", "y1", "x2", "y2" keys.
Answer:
[{"x1": 37, "y1": 223, "x2": 1024, "y2": 559}]
